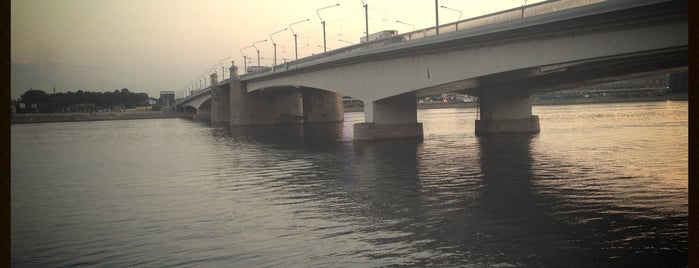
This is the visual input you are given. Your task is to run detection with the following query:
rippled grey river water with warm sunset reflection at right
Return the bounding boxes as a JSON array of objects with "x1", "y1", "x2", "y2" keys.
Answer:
[{"x1": 11, "y1": 101, "x2": 688, "y2": 267}]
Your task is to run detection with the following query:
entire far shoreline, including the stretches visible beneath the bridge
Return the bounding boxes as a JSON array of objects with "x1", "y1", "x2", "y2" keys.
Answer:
[{"x1": 10, "y1": 93, "x2": 689, "y2": 124}]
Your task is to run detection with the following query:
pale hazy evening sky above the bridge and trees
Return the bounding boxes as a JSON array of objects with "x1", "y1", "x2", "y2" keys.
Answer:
[{"x1": 10, "y1": 0, "x2": 539, "y2": 99}]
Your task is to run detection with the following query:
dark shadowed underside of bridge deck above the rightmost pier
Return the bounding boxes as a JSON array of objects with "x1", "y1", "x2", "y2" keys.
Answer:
[{"x1": 416, "y1": 47, "x2": 688, "y2": 97}]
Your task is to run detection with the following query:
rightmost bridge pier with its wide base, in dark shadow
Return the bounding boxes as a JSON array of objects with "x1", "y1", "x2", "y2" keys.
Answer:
[{"x1": 476, "y1": 89, "x2": 539, "y2": 135}]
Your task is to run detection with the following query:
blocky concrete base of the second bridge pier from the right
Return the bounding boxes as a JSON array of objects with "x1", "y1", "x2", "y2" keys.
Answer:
[{"x1": 354, "y1": 123, "x2": 423, "y2": 140}]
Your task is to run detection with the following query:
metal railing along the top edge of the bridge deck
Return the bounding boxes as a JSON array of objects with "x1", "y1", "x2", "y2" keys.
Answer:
[{"x1": 241, "y1": 0, "x2": 607, "y2": 78}]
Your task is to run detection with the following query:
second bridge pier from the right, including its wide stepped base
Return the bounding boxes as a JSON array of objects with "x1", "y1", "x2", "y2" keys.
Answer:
[{"x1": 354, "y1": 92, "x2": 423, "y2": 140}]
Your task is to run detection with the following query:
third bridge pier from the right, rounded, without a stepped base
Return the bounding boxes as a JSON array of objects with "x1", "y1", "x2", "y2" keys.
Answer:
[{"x1": 303, "y1": 89, "x2": 345, "y2": 123}]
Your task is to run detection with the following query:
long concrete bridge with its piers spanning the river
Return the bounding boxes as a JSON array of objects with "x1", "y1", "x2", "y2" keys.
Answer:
[{"x1": 177, "y1": 0, "x2": 688, "y2": 140}]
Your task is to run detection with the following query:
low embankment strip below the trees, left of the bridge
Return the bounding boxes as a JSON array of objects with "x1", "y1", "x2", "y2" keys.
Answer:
[{"x1": 10, "y1": 112, "x2": 192, "y2": 124}]
